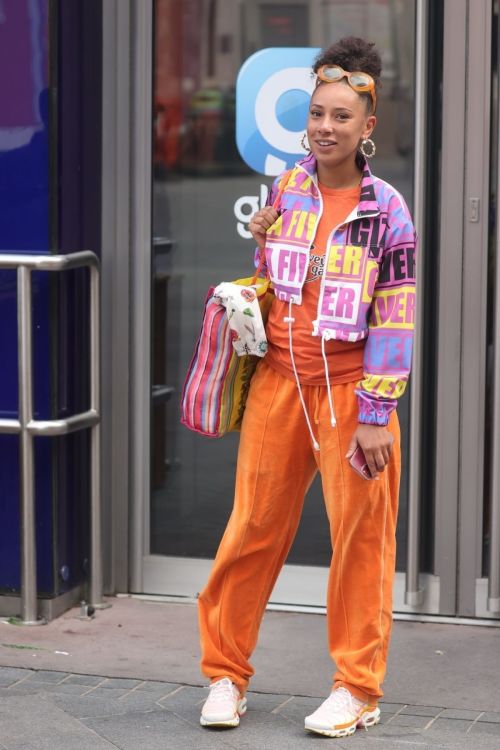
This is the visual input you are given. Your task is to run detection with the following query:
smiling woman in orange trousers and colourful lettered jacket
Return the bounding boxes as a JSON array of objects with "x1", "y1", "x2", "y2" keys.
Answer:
[{"x1": 199, "y1": 37, "x2": 415, "y2": 737}]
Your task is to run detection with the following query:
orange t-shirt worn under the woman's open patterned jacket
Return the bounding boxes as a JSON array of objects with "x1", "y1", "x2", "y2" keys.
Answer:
[{"x1": 266, "y1": 184, "x2": 365, "y2": 385}]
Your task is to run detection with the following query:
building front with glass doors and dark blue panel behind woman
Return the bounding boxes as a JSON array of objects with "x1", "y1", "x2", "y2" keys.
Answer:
[{"x1": 0, "y1": 0, "x2": 500, "y2": 621}]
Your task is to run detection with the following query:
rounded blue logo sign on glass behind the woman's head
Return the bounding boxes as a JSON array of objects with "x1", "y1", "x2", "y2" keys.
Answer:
[{"x1": 236, "y1": 47, "x2": 320, "y2": 175}]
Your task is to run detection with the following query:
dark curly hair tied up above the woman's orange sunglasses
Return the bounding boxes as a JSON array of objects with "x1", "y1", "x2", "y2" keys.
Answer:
[{"x1": 313, "y1": 36, "x2": 382, "y2": 112}]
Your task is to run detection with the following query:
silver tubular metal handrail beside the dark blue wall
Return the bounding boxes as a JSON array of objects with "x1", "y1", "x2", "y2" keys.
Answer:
[{"x1": 0, "y1": 250, "x2": 104, "y2": 625}]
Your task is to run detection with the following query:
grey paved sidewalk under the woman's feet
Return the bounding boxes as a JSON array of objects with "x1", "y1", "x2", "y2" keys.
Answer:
[{"x1": 0, "y1": 598, "x2": 500, "y2": 750}]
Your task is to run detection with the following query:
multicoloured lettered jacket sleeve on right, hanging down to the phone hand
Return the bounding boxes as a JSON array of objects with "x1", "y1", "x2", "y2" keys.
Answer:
[{"x1": 356, "y1": 194, "x2": 416, "y2": 425}]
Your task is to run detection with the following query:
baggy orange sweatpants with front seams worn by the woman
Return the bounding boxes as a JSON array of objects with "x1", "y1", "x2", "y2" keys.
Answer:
[{"x1": 199, "y1": 361, "x2": 401, "y2": 704}]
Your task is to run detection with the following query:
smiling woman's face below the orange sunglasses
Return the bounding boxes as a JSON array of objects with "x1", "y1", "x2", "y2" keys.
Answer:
[{"x1": 307, "y1": 81, "x2": 376, "y2": 176}]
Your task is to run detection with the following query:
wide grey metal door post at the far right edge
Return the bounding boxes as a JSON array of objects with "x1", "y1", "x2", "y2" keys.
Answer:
[{"x1": 434, "y1": 0, "x2": 498, "y2": 619}]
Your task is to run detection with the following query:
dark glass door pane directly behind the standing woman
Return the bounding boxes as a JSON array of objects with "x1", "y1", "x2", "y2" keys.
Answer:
[{"x1": 142, "y1": 0, "x2": 422, "y2": 605}]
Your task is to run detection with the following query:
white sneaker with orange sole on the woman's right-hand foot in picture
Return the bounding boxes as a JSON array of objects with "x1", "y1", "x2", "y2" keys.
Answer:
[{"x1": 305, "y1": 687, "x2": 380, "y2": 737}]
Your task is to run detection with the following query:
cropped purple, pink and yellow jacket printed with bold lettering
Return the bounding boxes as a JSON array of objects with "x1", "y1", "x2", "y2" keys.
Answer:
[{"x1": 265, "y1": 155, "x2": 416, "y2": 425}]
